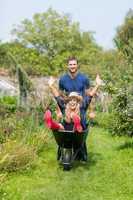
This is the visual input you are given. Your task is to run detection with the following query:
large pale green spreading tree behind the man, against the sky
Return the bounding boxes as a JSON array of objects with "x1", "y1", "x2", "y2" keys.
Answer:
[{"x1": 8, "y1": 8, "x2": 101, "y2": 75}]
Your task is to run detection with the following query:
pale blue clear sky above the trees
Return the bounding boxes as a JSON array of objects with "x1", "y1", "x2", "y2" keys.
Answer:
[{"x1": 0, "y1": 0, "x2": 133, "y2": 49}]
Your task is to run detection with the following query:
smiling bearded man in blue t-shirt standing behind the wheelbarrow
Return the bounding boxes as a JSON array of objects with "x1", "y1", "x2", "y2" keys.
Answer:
[{"x1": 59, "y1": 57, "x2": 90, "y2": 161}]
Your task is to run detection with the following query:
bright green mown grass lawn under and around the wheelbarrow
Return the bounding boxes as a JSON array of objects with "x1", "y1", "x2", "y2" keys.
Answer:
[{"x1": 0, "y1": 128, "x2": 133, "y2": 200}]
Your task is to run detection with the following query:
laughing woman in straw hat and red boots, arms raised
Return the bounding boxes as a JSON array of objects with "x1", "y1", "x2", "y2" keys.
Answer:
[{"x1": 44, "y1": 75, "x2": 101, "y2": 133}]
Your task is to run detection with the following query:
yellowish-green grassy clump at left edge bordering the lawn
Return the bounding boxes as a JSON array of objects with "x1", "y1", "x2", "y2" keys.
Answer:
[{"x1": 0, "y1": 140, "x2": 36, "y2": 172}]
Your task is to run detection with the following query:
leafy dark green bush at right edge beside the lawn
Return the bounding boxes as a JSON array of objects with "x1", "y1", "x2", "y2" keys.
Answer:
[{"x1": 107, "y1": 86, "x2": 133, "y2": 136}]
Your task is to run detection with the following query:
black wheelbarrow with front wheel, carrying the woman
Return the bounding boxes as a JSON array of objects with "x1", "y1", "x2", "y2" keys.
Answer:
[{"x1": 53, "y1": 126, "x2": 88, "y2": 171}]
